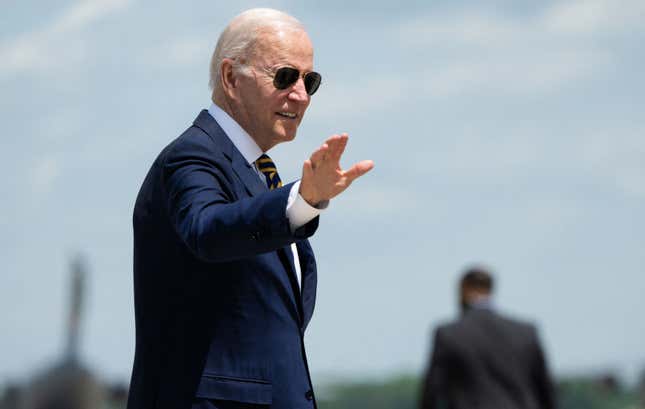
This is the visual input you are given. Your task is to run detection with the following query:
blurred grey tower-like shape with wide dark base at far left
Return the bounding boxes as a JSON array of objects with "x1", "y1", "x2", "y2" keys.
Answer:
[{"x1": 0, "y1": 255, "x2": 127, "y2": 409}]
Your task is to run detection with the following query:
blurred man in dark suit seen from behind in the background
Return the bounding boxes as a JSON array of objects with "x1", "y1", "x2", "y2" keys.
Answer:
[{"x1": 421, "y1": 267, "x2": 555, "y2": 409}]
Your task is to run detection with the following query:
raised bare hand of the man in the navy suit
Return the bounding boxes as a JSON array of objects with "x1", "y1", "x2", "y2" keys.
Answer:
[{"x1": 299, "y1": 133, "x2": 374, "y2": 206}]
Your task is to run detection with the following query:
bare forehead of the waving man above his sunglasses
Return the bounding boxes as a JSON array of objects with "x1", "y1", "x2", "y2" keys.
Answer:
[{"x1": 253, "y1": 29, "x2": 314, "y2": 70}]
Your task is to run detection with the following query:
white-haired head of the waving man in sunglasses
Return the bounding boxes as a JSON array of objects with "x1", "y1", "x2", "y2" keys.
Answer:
[{"x1": 210, "y1": 9, "x2": 313, "y2": 151}]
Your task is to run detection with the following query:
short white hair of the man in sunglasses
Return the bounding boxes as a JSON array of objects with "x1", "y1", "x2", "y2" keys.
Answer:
[{"x1": 208, "y1": 8, "x2": 305, "y2": 91}]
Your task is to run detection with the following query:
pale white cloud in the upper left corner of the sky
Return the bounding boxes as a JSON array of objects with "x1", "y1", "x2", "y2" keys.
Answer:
[{"x1": 0, "y1": 0, "x2": 129, "y2": 78}]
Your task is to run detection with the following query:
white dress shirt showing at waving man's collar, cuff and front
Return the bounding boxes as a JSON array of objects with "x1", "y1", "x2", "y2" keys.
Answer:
[{"x1": 208, "y1": 104, "x2": 329, "y2": 288}]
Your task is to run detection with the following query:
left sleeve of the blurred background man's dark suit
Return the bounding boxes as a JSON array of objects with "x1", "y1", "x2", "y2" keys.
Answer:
[{"x1": 420, "y1": 328, "x2": 446, "y2": 409}]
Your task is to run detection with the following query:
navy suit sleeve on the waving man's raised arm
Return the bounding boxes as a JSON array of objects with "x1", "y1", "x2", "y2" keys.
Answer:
[{"x1": 163, "y1": 140, "x2": 318, "y2": 262}]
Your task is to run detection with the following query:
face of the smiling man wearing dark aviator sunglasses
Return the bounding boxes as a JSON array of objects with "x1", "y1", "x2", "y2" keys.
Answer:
[{"x1": 232, "y1": 30, "x2": 313, "y2": 151}]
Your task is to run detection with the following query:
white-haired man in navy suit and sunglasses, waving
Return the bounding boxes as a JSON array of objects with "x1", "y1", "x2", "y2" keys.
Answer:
[{"x1": 128, "y1": 9, "x2": 373, "y2": 409}]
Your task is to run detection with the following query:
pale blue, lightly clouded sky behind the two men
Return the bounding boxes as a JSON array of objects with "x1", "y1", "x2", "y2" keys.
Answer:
[{"x1": 0, "y1": 0, "x2": 645, "y2": 383}]
